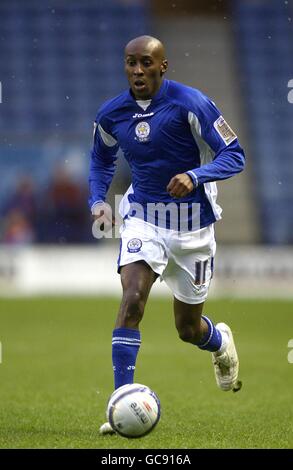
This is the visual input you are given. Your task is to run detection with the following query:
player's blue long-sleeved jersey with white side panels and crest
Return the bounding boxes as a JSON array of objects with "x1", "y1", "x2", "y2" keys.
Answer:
[{"x1": 89, "y1": 79, "x2": 245, "y2": 228}]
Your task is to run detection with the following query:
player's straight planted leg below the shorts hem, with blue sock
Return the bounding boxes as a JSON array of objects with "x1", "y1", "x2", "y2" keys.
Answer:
[{"x1": 112, "y1": 261, "x2": 157, "y2": 389}]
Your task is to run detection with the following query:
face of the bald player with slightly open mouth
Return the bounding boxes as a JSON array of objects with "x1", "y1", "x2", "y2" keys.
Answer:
[{"x1": 125, "y1": 45, "x2": 167, "y2": 100}]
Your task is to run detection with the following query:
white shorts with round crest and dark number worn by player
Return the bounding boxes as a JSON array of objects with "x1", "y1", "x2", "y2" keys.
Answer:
[{"x1": 118, "y1": 217, "x2": 216, "y2": 304}]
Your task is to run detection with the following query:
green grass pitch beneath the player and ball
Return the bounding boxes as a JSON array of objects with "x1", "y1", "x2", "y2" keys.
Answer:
[{"x1": 0, "y1": 298, "x2": 293, "y2": 449}]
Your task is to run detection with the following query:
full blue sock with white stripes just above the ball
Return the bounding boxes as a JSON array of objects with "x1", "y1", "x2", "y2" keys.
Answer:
[{"x1": 112, "y1": 328, "x2": 141, "y2": 390}]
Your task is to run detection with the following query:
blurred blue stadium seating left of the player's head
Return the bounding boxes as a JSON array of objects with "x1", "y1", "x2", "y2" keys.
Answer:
[{"x1": 0, "y1": 0, "x2": 148, "y2": 215}]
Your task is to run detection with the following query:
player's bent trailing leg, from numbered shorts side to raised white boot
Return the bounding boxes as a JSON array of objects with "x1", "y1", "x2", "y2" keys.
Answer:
[{"x1": 163, "y1": 225, "x2": 239, "y2": 390}]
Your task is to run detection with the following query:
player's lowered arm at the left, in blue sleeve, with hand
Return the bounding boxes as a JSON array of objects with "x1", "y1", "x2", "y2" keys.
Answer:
[{"x1": 89, "y1": 114, "x2": 119, "y2": 218}]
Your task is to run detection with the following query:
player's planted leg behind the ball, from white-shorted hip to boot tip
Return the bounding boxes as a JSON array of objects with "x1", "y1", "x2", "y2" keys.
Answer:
[{"x1": 100, "y1": 218, "x2": 167, "y2": 434}]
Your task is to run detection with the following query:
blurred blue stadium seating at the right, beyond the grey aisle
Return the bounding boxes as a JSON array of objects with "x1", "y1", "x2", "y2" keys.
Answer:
[{"x1": 232, "y1": 0, "x2": 293, "y2": 244}]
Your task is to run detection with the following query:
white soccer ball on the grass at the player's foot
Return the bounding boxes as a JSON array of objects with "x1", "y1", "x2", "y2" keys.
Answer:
[{"x1": 106, "y1": 383, "x2": 161, "y2": 437}]
